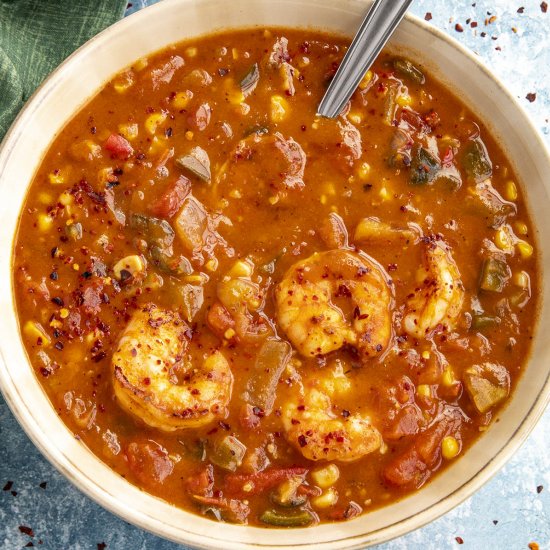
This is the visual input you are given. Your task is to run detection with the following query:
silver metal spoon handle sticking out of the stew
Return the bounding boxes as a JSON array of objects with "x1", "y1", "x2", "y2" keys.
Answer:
[{"x1": 318, "y1": 0, "x2": 412, "y2": 118}]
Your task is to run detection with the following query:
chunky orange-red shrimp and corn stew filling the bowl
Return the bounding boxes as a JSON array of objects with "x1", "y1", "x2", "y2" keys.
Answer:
[{"x1": 13, "y1": 28, "x2": 539, "y2": 527}]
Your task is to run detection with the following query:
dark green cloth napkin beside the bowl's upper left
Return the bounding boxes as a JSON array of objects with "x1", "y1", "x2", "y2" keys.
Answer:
[{"x1": 0, "y1": 0, "x2": 127, "y2": 140}]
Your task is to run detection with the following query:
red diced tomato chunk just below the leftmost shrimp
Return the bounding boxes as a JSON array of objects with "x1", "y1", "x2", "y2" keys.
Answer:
[{"x1": 126, "y1": 442, "x2": 174, "y2": 485}]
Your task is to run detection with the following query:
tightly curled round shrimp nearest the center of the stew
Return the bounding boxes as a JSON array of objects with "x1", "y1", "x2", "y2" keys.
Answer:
[{"x1": 275, "y1": 249, "x2": 393, "y2": 357}]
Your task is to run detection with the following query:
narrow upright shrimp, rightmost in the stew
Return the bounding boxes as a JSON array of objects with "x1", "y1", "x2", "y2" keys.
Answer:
[{"x1": 403, "y1": 240, "x2": 464, "y2": 338}]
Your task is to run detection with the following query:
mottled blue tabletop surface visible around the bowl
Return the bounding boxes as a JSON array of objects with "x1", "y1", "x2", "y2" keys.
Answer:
[{"x1": 0, "y1": 0, "x2": 550, "y2": 550}]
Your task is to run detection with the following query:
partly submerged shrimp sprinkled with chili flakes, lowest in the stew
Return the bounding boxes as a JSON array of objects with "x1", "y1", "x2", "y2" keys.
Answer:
[{"x1": 282, "y1": 380, "x2": 382, "y2": 462}]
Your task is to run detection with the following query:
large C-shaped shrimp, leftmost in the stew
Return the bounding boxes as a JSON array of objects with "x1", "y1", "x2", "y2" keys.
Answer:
[{"x1": 111, "y1": 304, "x2": 233, "y2": 431}]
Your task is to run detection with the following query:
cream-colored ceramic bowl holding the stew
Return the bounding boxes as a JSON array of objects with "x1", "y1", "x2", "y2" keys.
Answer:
[{"x1": 0, "y1": 0, "x2": 550, "y2": 550}]
